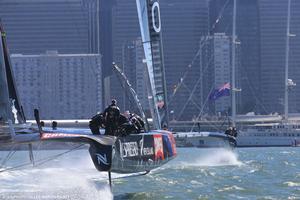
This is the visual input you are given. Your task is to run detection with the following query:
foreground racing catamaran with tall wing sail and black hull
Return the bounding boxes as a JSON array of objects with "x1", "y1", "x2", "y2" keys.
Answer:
[{"x1": 0, "y1": 0, "x2": 177, "y2": 180}]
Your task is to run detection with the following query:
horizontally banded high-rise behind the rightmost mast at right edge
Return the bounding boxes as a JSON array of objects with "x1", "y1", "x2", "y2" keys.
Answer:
[{"x1": 259, "y1": 0, "x2": 300, "y2": 113}]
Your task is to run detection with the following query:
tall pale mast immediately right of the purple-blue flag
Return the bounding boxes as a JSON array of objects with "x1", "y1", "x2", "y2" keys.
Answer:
[{"x1": 231, "y1": 0, "x2": 236, "y2": 127}]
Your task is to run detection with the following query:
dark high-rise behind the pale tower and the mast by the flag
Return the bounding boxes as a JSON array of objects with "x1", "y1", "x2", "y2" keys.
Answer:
[{"x1": 209, "y1": 0, "x2": 262, "y2": 114}]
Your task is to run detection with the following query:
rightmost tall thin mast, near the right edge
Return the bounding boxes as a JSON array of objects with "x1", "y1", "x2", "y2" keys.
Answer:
[{"x1": 284, "y1": 0, "x2": 291, "y2": 121}]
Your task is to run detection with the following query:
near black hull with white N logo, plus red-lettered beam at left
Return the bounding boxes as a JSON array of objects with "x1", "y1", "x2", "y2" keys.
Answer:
[{"x1": 41, "y1": 129, "x2": 177, "y2": 173}]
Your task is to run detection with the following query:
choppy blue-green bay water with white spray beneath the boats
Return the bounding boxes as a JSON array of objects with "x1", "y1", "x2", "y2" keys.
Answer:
[{"x1": 0, "y1": 148, "x2": 300, "y2": 200}]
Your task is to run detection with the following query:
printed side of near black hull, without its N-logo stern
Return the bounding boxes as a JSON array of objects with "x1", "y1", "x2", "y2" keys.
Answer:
[{"x1": 111, "y1": 133, "x2": 176, "y2": 173}]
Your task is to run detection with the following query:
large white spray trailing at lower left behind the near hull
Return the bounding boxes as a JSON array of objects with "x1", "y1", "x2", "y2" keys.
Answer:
[{"x1": 0, "y1": 150, "x2": 113, "y2": 200}]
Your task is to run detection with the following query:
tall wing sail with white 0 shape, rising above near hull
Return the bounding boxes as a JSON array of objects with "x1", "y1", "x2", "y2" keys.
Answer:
[{"x1": 136, "y1": 0, "x2": 168, "y2": 129}]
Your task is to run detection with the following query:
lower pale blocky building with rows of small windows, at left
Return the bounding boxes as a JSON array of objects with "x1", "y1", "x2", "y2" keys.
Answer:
[{"x1": 11, "y1": 51, "x2": 102, "y2": 119}]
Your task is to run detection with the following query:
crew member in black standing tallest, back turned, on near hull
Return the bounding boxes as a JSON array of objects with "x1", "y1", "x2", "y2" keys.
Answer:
[{"x1": 103, "y1": 99, "x2": 120, "y2": 135}]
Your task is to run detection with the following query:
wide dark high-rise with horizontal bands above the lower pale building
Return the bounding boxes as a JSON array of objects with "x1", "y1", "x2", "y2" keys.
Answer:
[{"x1": 0, "y1": 0, "x2": 99, "y2": 54}]
